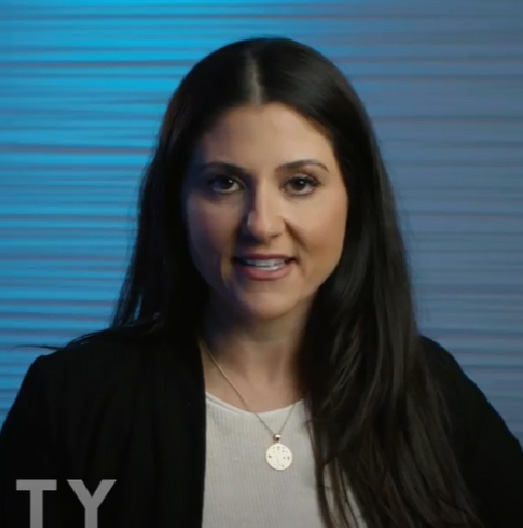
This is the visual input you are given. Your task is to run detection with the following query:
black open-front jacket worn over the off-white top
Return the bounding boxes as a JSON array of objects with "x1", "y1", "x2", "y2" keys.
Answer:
[{"x1": 0, "y1": 330, "x2": 523, "y2": 528}]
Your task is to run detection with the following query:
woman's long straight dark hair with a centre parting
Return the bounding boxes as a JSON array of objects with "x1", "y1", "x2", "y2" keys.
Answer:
[{"x1": 31, "y1": 38, "x2": 481, "y2": 528}]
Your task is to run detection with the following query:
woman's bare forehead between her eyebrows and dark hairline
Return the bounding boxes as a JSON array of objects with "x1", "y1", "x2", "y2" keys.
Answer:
[{"x1": 195, "y1": 103, "x2": 335, "y2": 165}]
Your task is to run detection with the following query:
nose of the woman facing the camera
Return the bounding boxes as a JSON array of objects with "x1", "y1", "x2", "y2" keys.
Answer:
[{"x1": 242, "y1": 186, "x2": 284, "y2": 242}]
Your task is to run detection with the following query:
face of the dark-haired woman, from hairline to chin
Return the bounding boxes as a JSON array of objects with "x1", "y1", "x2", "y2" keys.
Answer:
[{"x1": 184, "y1": 103, "x2": 348, "y2": 319}]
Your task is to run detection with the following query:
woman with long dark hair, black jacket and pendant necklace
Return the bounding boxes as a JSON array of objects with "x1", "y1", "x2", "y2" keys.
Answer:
[{"x1": 0, "y1": 39, "x2": 523, "y2": 528}]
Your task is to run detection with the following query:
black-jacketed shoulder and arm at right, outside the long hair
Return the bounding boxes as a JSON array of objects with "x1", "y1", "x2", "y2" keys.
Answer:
[{"x1": 421, "y1": 337, "x2": 523, "y2": 526}]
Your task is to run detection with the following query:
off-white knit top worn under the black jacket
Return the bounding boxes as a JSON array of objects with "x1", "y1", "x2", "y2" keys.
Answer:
[{"x1": 202, "y1": 393, "x2": 365, "y2": 528}]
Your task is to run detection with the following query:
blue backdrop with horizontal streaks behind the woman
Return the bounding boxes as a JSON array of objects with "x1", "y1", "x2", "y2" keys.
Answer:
[{"x1": 0, "y1": 0, "x2": 523, "y2": 440}]
